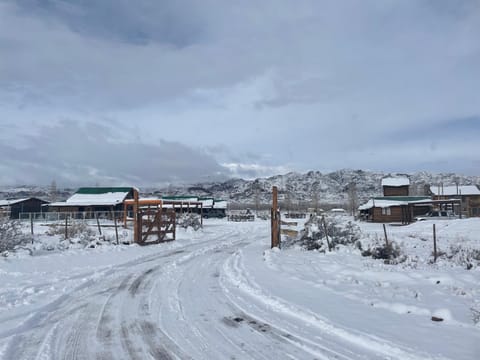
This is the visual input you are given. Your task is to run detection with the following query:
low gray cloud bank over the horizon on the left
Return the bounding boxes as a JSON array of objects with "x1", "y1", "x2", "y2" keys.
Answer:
[{"x1": 0, "y1": 120, "x2": 227, "y2": 186}]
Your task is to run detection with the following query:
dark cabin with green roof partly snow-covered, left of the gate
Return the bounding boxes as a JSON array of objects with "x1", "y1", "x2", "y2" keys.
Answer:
[{"x1": 48, "y1": 187, "x2": 138, "y2": 217}]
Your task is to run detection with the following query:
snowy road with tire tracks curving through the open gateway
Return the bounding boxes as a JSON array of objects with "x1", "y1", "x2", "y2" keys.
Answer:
[{"x1": 0, "y1": 221, "x2": 480, "y2": 359}]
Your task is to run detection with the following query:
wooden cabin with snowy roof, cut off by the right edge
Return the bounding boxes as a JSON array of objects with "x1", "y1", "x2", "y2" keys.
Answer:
[{"x1": 429, "y1": 185, "x2": 480, "y2": 217}]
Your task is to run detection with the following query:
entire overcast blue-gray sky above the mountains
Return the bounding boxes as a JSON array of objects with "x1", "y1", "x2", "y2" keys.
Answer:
[{"x1": 0, "y1": 0, "x2": 480, "y2": 186}]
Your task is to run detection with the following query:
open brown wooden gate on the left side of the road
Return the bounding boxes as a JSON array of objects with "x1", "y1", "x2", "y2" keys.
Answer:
[{"x1": 136, "y1": 208, "x2": 176, "y2": 245}]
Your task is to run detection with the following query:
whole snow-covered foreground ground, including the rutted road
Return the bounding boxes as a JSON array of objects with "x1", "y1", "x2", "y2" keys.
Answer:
[{"x1": 0, "y1": 215, "x2": 480, "y2": 360}]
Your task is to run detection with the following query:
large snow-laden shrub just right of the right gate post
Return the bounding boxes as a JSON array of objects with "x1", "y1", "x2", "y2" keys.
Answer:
[{"x1": 295, "y1": 216, "x2": 361, "y2": 250}]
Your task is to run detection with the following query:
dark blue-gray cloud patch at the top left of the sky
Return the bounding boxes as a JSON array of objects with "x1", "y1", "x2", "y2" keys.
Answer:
[{"x1": 16, "y1": 0, "x2": 206, "y2": 47}]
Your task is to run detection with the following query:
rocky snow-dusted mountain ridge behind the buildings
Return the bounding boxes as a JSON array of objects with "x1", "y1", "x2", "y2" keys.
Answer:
[{"x1": 150, "y1": 169, "x2": 480, "y2": 205}]
